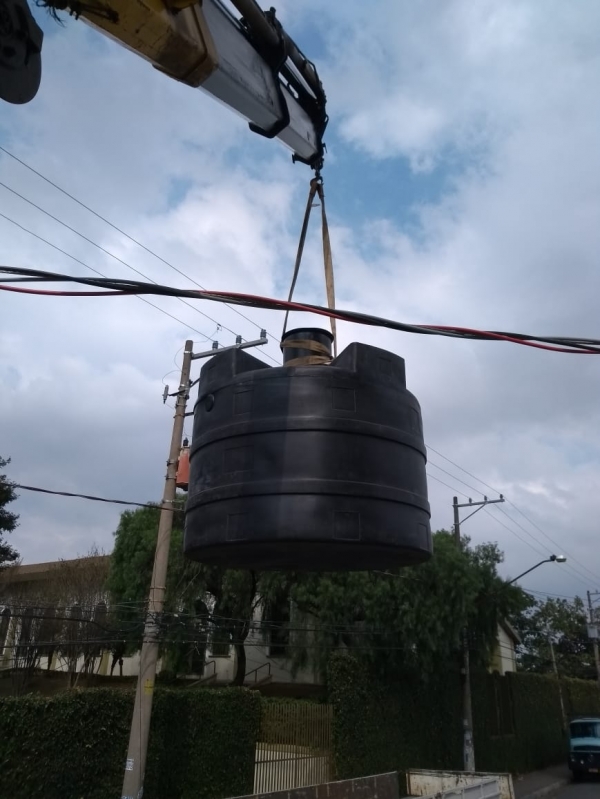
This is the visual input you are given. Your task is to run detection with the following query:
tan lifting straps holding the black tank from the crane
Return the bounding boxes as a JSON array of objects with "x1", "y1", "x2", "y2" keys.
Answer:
[{"x1": 281, "y1": 175, "x2": 337, "y2": 366}]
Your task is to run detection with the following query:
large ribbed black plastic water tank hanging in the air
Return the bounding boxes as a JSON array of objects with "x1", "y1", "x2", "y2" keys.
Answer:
[{"x1": 184, "y1": 329, "x2": 431, "y2": 571}]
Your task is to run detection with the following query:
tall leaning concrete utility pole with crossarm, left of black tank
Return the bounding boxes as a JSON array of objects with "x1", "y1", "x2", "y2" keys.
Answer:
[{"x1": 121, "y1": 330, "x2": 268, "y2": 799}]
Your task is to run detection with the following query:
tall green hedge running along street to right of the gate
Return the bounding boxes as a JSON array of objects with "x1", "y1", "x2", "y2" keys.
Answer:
[{"x1": 328, "y1": 655, "x2": 600, "y2": 785}]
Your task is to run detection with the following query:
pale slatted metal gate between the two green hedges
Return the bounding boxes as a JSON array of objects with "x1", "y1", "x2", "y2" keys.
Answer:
[{"x1": 254, "y1": 701, "x2": 333, "y2": 794}]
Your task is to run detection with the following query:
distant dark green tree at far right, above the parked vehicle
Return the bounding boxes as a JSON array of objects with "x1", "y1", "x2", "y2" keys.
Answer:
[{"x1": 515, "y1": 597, "x2": 597, "y2": 680}]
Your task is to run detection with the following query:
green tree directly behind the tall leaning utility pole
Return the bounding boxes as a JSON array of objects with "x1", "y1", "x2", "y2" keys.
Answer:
[{"x1": 108, "y1": 504, "x2": 288, "y2": 685}]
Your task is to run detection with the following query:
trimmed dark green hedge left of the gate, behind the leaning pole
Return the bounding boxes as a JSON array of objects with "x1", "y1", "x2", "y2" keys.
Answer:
[{"x1": 0, "y1": 688, "x2": 261, "y2": 799}]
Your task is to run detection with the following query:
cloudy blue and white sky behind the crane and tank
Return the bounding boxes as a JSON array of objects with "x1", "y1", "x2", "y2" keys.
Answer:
[{"x1": 0, "y1": 0, "x2": 600, "y2": 596}]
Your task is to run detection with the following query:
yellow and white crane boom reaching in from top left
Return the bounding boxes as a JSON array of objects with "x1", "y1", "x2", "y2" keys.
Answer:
[{"x1": 0, "y1": 0, "x2": 327, "y2": 169}]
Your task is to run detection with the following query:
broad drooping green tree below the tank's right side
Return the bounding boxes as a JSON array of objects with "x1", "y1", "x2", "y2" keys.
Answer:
[{"x1": 290, "y1": 530, "x2": 525, "y2": 675}]
